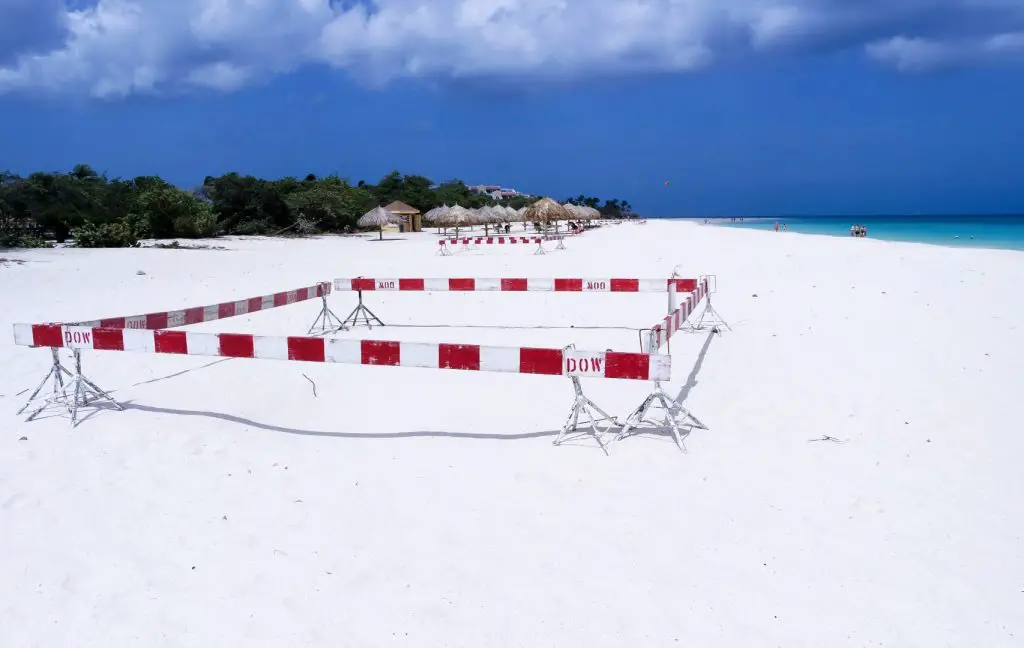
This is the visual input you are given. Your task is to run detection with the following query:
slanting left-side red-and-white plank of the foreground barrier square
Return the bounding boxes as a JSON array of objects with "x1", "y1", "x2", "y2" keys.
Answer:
[{"x1": 68, "y1": 282, "x2": 331, "y2": 331}]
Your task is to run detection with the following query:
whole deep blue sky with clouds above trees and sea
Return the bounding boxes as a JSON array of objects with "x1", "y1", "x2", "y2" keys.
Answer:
[{"x1": 0, "y1": 0, "x2": 1024, "y2": 216}]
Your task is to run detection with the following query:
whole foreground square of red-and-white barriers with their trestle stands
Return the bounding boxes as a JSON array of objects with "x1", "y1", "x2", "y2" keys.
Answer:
[{"x1": 14, "y1": 268, "x2": 728, "y2": 451}]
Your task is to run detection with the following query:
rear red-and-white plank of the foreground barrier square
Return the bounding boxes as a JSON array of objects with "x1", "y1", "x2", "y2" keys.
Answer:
[{"x1": 334, "y1": 276, "x2": 697, "y2": 293}]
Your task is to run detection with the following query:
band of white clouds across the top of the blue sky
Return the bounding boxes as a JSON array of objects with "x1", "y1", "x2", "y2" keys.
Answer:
[{"x1": 0, "y1": 0, "x2": 1024, "y2": 96}]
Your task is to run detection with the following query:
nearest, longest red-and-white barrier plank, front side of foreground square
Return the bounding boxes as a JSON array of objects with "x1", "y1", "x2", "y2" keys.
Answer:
[{"x1": 14, "y1": 325, "x2": 672, "y2": 381}]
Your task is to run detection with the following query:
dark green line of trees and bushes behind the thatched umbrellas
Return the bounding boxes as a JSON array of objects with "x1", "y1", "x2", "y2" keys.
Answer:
[{"x1": 0, "y1": 164, "x2": 634, "y2": 248}]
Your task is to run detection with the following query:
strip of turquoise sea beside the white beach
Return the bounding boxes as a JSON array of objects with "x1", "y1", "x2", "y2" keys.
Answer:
[{"x1": 689, "y1": 215, "x2": 1024, "y2": 250}]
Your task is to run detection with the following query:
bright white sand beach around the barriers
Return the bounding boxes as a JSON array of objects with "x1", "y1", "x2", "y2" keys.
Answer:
[{"x1": 0, "y1": 221, "x2": 1024, "y2": 648}]
